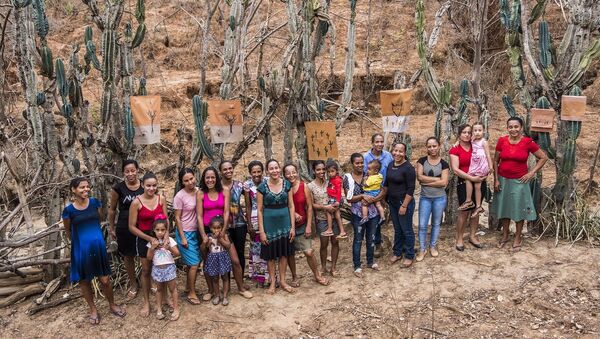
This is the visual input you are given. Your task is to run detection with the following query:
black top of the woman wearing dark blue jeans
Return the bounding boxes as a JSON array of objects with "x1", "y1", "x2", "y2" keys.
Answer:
[{"x1": 383, "y1": 161, "x2": 417, "y2": 204}]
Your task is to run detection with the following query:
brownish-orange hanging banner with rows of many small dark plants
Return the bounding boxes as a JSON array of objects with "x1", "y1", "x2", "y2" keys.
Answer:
[{"x1": 304, "y1": 121, "x2": 338, "y2": 160}]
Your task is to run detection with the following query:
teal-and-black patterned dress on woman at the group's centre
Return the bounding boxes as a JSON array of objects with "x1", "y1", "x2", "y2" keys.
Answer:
[{"x1": 257, "y1": 180, "x2": 294, "y2": 260}]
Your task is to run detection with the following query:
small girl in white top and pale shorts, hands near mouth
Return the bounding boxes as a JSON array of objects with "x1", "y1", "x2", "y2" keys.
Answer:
[{"x1": 146, "y1": 213, "x2": 179, "y2": 321}]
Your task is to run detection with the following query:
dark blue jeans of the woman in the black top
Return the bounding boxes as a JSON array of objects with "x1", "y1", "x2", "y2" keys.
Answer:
[{"x1": 389, "y1": 199, "x2": 415, "y2": 259}]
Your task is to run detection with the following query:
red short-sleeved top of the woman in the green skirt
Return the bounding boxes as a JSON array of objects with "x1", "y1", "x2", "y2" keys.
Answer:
[{"x1": 496, "y1": 135, "x2": 540, "y2": 179}]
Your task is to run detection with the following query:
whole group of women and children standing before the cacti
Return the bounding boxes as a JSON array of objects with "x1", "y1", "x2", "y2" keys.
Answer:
[{"x1": 63, "y1": 117, "x2": 547, "y2": 324}]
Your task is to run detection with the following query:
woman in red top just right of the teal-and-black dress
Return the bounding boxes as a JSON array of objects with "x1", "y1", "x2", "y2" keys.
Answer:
[{"x1": 283, "y1": 164, "x2": 329, "y2": 287}]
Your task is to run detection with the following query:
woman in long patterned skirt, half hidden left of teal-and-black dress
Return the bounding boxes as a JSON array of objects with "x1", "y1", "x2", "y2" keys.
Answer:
[{"x1": 244, "y1": 160, "x2": 269, "y2": 287}]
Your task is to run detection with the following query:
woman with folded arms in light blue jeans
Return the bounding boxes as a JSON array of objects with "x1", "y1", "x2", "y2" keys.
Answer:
[{"x1": 417, "y1": 137, "x2": 450, "y2": 261}]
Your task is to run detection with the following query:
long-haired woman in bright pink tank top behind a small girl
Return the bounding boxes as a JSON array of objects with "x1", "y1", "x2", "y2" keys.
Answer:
[{"x1": 196, "y1": 166, "x2": 252, "y2": 301}]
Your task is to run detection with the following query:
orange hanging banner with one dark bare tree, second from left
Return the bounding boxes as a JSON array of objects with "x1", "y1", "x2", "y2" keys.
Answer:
[{"x1": 208, "y1": 100, "x2": 244, "y2": 144}]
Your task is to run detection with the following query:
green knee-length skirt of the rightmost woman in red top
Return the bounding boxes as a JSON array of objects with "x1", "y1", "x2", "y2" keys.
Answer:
[{"x1": 492, "y1": 176, "x2": 537, "y2": 221}]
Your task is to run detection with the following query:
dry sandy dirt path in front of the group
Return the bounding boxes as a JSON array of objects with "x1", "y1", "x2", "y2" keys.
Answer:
[{"x1": 0, "y1": 225, "x2": 600, "y2": 338}]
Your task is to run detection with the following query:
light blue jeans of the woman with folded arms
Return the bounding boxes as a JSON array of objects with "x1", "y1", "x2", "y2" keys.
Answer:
[{"x1": 419, "y1": 195, "x2": 448, "y2": 252}]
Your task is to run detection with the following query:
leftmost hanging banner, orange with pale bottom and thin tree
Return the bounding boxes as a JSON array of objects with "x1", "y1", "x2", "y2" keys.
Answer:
[{"x1": 130, "y1": 95, "x2": 161, "y2": 145}]
